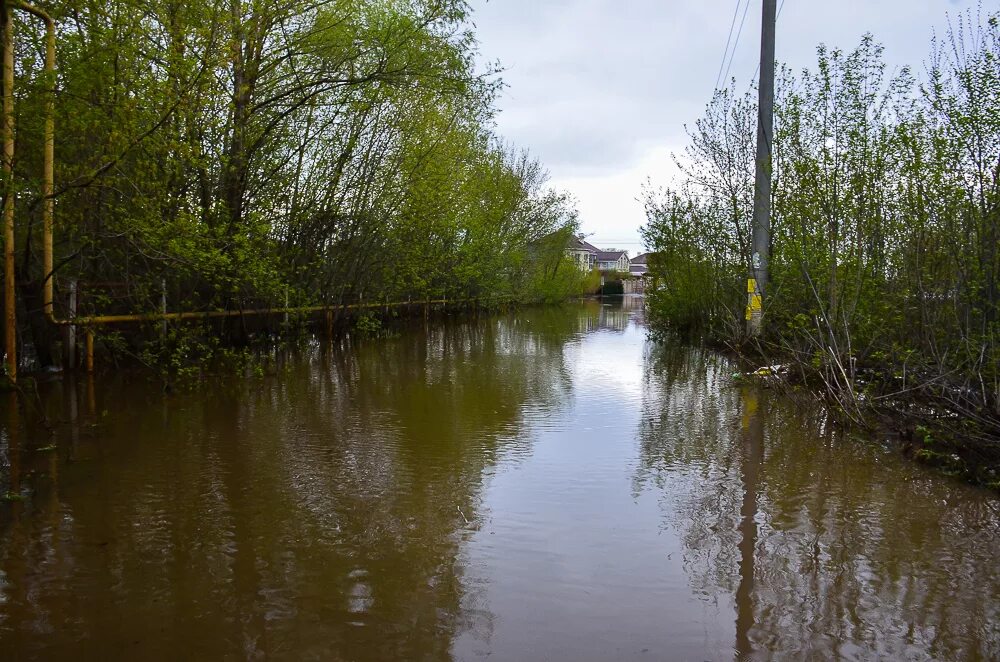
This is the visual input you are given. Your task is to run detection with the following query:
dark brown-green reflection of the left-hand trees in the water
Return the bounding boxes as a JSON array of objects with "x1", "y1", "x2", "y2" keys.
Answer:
[{"x1": 0, "y1": 309, "x2": 579, "y2": 659}]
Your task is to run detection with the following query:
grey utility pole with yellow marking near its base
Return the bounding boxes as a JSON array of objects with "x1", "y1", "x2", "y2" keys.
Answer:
[{"x1": 747, "y1": 0, "x2": 777, "y2": 338}]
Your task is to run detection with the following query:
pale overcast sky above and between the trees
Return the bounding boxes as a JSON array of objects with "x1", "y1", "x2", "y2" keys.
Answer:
[{"x1": 471, "y1": 0, "x2": 976, "y2": 256}]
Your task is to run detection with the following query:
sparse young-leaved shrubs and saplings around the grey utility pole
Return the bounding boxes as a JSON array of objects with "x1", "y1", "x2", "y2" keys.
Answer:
[{"x1": 644, "y1": 11, "x2": 1000, "y2": 478}]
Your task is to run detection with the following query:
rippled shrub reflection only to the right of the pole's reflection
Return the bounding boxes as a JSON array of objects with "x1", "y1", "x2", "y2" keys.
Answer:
[{"x1": 744, "y1": 403, "x2": 1000, "y2": 659}]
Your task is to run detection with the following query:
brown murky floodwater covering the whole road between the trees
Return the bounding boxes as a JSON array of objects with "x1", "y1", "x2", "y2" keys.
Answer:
[{"x1": 0, "y1": 299, "x2": 1000, "y2": 661}]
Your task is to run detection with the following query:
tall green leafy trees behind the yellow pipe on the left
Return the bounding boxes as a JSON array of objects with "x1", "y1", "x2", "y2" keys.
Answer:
[{"x1": 4, "y1": 0, "x2": 579, "y2": 365}]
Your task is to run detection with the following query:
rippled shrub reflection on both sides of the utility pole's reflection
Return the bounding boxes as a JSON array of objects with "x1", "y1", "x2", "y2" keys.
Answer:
[{"x1": 635, "y1": 348, "x2": 1000, "y2": 659}]
